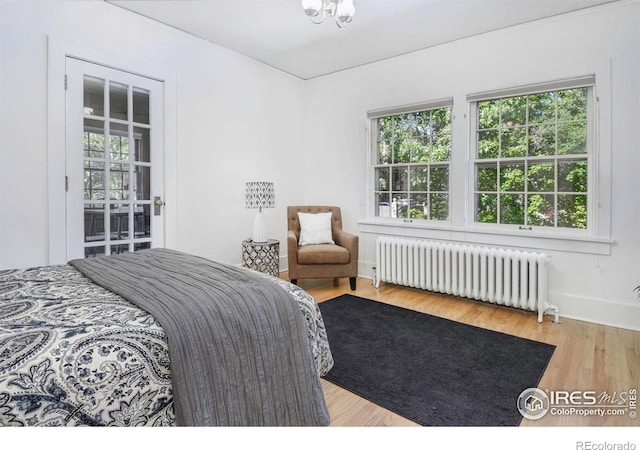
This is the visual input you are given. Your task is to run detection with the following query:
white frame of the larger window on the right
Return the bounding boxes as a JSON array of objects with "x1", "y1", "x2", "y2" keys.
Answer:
[{"x1": 466, "y1": 75, "x2": 598, "y2": 237}]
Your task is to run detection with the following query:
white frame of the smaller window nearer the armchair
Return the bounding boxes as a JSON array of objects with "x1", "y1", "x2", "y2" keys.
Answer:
[{"x1": 367, "y1": 97, "x2": 454, "y2": 226}]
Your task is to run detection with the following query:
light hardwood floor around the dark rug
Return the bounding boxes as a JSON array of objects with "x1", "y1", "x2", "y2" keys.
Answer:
[{"x1": 292, "y1": 273, "x2": 640, "y2": 427}]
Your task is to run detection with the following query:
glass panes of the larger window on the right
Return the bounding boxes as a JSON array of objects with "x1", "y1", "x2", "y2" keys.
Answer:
[{"x1": 472, "y1": 78, "x2": 592, "y2": 229}]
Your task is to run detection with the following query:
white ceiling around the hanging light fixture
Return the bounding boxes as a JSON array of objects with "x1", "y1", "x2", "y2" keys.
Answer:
[{"x1": 106, "y1": 0, "x2": 618, "y2": 79}]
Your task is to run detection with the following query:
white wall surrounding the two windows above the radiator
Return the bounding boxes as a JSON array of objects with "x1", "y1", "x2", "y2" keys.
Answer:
[{"x1": 304, "y1": 2, "x2": 640, "y2": 329}]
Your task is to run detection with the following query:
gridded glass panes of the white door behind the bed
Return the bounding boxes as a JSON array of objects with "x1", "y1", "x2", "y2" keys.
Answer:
[{"x1": 83, "y1": 76, "x2": 153, "y2": 257}]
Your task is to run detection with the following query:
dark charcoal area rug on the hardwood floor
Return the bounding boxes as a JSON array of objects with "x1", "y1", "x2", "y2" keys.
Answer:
[{"x1": 320, "y1": 294, "x2": 555, "y2": 426}]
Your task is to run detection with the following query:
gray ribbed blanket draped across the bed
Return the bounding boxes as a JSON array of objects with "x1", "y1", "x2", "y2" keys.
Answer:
[{"x1": 69, "y1": 249, "x2": 329, "y2": 426}]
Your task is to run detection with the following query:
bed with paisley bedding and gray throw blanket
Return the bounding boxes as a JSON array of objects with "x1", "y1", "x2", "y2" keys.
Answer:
[{"x1": 0, "y1": 249, "x2": 333, "y2": 426}]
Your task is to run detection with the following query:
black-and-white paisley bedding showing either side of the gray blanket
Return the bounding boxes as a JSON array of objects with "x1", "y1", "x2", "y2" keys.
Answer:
[{"x1": 0, "y1": 264, "x2": 333, "y2": 426}]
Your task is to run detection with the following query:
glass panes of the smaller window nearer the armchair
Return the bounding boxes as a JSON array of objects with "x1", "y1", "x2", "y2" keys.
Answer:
[{"x1": 369, "y1": 100, "x2": 452, "y2": 220}]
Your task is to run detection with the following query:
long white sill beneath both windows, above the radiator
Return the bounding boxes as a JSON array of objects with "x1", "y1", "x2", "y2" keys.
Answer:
[{"x1": 358, "y1": 219, "x2": 615, "y2": 255}]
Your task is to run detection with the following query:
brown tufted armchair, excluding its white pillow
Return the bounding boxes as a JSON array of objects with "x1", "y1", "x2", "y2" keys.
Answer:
[{"x1": 287, "y1": 206, "x2": 358, "y2": 290}]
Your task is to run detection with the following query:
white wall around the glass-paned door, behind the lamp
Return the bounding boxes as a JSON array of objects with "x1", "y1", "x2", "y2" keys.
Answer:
[{"x1": 0, "y1": 1, "x2": 304, "y2": 268}]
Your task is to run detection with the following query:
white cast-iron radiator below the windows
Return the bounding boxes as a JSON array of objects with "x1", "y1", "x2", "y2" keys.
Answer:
[{"x1": 374, "y1": 236, "x2": 559, "y2": 322}]
